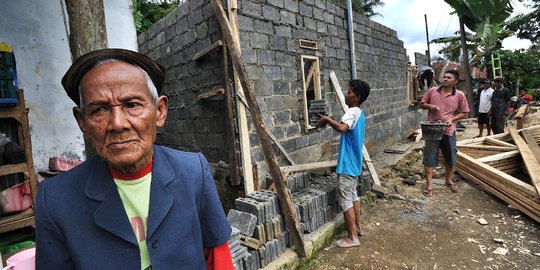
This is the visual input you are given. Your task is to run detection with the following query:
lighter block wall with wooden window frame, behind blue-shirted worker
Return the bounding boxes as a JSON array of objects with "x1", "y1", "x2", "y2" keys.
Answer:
[{"x1": 238, "y1": 0, "x2": 421, "y2": 186}]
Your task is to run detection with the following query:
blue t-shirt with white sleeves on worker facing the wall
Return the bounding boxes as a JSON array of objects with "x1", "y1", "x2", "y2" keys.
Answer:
[{"x1": 336, "y1": 107, "x2": 366, "y2": 176}]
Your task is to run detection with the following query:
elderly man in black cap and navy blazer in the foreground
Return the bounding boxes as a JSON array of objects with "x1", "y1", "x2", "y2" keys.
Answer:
[{"x1": 36, "y1": 49, "x2": 232, "y2": 270}]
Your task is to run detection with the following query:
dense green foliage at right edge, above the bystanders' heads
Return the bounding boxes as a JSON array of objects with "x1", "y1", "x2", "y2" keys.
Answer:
[{"x1": 500, "y1": 49, "x2": 540, "y2": 93}]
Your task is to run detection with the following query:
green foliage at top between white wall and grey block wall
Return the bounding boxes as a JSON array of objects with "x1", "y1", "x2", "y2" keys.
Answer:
[{"x1": 132, "y1": 0, "x2": 180, "y2": 35}]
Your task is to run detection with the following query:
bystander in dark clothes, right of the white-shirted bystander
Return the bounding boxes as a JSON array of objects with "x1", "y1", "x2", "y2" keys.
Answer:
[{"x1": 491, "y1": 77, "x2": 511, "y2": 134}]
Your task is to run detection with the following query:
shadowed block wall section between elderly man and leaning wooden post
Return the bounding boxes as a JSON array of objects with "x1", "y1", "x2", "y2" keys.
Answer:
[{"x1": 138, "y1": 0, "x2": 229, "y2": 163}]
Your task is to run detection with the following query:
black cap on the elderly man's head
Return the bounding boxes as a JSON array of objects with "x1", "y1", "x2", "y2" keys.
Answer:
[{"x1": 62, "y1": 49, "x2": 165, "y2": 106}]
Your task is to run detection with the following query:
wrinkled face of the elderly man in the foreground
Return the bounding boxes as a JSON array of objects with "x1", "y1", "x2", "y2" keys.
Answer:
[{"x1": 73, "y1": 61, "x2": 168, "y2": 173}]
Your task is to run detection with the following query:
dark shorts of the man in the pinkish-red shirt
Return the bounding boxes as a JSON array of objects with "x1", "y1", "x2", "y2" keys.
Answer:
[{"x1": 422, "y1": 135, "x2": 457, "y2": 167}]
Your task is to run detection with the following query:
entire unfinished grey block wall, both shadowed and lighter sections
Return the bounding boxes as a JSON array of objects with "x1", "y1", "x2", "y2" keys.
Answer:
[{"x1": 138, "y1": 0, "x2": 423, "y2": 188}]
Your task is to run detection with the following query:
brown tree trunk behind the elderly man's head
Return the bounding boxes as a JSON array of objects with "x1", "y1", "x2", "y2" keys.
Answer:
[{"x1": 66, "y1": 0, "x2": 107, "y2": 159}]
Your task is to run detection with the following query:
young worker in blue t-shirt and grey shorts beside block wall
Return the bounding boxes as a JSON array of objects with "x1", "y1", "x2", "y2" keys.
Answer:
[{"x1": 319, "y1": 80, "x2": 370, "y2": 247}]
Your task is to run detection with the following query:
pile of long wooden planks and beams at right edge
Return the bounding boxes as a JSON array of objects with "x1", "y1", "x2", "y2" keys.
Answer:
[{"x1": 457, "y1": 125, "x2": 540, "y2": 222}]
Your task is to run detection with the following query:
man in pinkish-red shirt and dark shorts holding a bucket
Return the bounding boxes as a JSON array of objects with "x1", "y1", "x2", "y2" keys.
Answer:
[{"x1": 420, "y1": 70, "x2": 469, "y2": 197}]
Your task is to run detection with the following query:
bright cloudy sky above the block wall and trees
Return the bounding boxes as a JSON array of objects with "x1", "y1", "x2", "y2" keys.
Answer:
[{"x1": 372, "y1": 0, "x2": 530, "y2": 62}]
